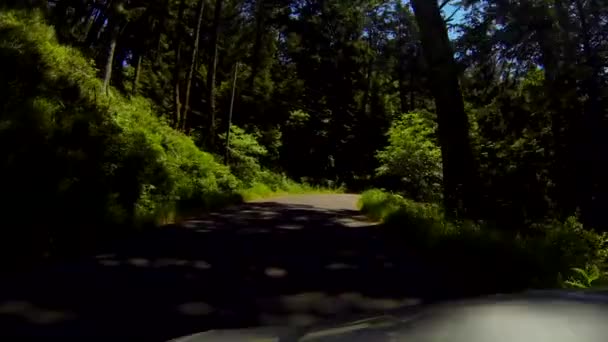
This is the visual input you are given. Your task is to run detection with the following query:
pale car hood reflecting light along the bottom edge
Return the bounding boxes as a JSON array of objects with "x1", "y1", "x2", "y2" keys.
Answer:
[{"x1": 173, "y1": 291, "x2": 608, "y2": 342}]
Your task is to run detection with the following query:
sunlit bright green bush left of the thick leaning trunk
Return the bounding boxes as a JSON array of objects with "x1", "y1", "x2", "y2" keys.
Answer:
[{"x1": 376, "y1": 111, "x2": 442, "y2": 202}]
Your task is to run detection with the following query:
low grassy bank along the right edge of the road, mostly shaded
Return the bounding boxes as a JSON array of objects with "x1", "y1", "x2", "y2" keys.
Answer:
[{"x1": 359, "y1": 190, "x2": 608, "y2": 293}]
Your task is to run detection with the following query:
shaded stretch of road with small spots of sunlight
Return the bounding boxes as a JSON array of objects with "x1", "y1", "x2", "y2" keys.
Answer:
[{"x1": 0, "y1": 203, "x2": 438, "y2": 341}]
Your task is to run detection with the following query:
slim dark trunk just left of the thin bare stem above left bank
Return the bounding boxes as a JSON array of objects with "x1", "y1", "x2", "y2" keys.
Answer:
[{"x1": 207, "y1": 0, "x2": 223, "y2": 148}]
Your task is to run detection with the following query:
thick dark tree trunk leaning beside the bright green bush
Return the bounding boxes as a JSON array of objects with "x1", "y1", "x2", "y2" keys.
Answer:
[{"x1": 412, "y1": 0, "x2": 480, "y2": 216}]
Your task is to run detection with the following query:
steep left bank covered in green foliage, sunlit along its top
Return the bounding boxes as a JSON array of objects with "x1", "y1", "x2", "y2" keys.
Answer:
[{"x1": 0, "y1": 12, "x2": 240, "y2": 262}]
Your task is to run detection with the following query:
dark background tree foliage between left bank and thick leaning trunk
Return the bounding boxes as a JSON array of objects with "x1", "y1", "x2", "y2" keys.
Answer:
[{"x1": 26, "y1": 0, "x2": 418, "y2": 187}]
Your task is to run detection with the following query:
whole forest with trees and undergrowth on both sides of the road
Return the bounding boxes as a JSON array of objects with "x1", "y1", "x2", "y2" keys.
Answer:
[{"x1": 0, "y1": 0, "x2": 608, "y2": 287}]
